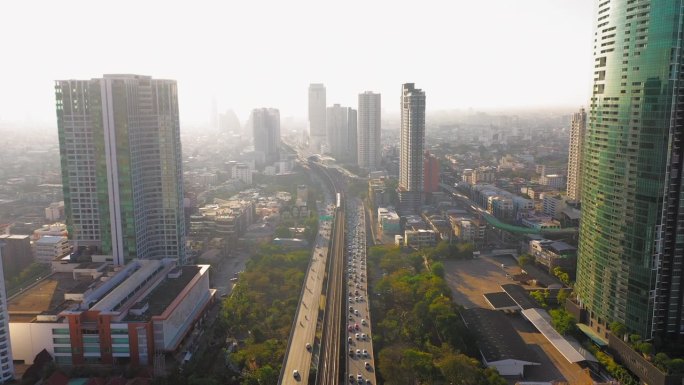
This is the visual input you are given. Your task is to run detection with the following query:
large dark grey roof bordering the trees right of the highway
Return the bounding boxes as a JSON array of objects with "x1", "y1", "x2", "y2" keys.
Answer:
[{"x1": 461, "y1": 308, "x2": 539, "y2": 365}]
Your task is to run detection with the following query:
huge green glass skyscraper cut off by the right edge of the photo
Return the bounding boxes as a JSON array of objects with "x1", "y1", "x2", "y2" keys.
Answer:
[{"x1": 576, "y1": 0, "x2": 684, "y2": 343}]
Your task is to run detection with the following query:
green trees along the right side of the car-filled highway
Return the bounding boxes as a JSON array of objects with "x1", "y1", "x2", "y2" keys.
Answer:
[{"x1": 369, "y1": 247, "x2": 506, "y2": 385}]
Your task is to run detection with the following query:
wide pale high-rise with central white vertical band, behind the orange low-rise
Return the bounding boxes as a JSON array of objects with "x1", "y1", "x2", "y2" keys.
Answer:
[{"x1": 55, "y1": 75, "x2": 185, "y2": 265}]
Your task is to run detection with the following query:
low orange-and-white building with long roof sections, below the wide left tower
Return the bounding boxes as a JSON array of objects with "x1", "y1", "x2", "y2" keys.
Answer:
[{"x1": 8, "y1": 259, "x2": 215, "y2": 365}]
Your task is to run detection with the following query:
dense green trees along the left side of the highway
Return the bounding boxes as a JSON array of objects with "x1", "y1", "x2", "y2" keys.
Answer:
[{"x1": 221, "y1": 245, "x2": 309, "y2": 385}]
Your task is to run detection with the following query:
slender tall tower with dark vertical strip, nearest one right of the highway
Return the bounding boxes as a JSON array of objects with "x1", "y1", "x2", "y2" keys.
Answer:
[{"x1": 398, "y1": 83, "x2": 425, "y2": 215}]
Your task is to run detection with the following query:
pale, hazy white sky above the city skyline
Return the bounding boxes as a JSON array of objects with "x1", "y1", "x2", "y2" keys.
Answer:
[{"x1": 0, "y1": 0, "x2": 595, "y2": 122}]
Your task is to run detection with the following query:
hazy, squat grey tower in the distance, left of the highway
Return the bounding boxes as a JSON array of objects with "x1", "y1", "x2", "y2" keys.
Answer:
[{"x1": 249, "y1": 108, "x2": 280, "y2": 167}]
